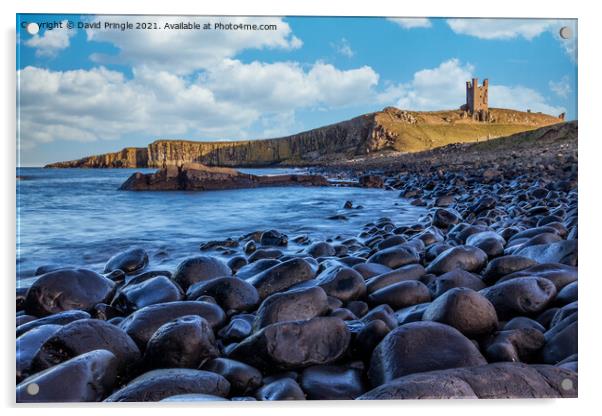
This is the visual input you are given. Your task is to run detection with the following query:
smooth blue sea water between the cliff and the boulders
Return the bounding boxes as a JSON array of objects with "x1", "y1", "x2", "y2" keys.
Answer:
[{"x1": 17, "y1": 168, "x2": 424, "y2": 285}]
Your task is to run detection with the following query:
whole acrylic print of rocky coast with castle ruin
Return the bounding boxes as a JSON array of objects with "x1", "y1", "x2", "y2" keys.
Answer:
[{"x1": 16, "y1": 14, "x2": 578, "y2": 402}]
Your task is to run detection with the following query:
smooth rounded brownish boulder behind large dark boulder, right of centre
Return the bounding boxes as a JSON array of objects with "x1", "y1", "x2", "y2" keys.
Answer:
[{"x1": 422, "y1": 288, "x2": 498, "y2": 337}]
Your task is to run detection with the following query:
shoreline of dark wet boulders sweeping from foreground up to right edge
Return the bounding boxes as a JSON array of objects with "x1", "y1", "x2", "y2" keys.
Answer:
[{"x1": 16, "y1": 123, "x2": 578, "y2": 402}]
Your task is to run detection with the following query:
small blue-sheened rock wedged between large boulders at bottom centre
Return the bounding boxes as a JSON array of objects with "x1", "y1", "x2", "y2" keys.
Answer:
[{"x1": 301, "y1": 365, "x2": 366, "y2": 400}]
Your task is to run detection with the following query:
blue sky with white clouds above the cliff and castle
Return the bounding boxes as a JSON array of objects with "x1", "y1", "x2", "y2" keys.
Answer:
[{"x1": 17, "y1": 14, "x2": 578, "y2": 166}]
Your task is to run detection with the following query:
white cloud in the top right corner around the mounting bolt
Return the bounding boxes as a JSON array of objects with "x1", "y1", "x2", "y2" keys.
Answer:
[{"x1": 447, "y1": 18, "x2": 577, "y2": 61}]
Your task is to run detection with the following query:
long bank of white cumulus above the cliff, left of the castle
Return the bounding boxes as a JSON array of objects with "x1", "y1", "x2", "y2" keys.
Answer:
[{"x1": 17, "y1": 60, "x2": 378, "y2": 148}]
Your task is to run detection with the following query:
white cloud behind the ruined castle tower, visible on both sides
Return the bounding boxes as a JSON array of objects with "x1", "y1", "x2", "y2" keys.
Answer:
[{"x1": 379, "y1": 59, "x2": 566, "y2": 115}]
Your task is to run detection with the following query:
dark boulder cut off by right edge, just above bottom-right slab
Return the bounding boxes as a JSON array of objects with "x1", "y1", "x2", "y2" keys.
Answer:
[{"x1": 541, "y1": 313, "x2": 579, "y2": 364}]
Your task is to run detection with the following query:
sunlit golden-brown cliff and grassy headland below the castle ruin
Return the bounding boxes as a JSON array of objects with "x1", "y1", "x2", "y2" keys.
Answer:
[{"x1": 46, "y1": 107, "x2": 562, "y2": 168}]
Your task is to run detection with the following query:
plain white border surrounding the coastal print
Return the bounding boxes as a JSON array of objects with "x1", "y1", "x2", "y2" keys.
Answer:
[{"x1": 0, "y1": 0, "x2": 602, "y2": 416}]
